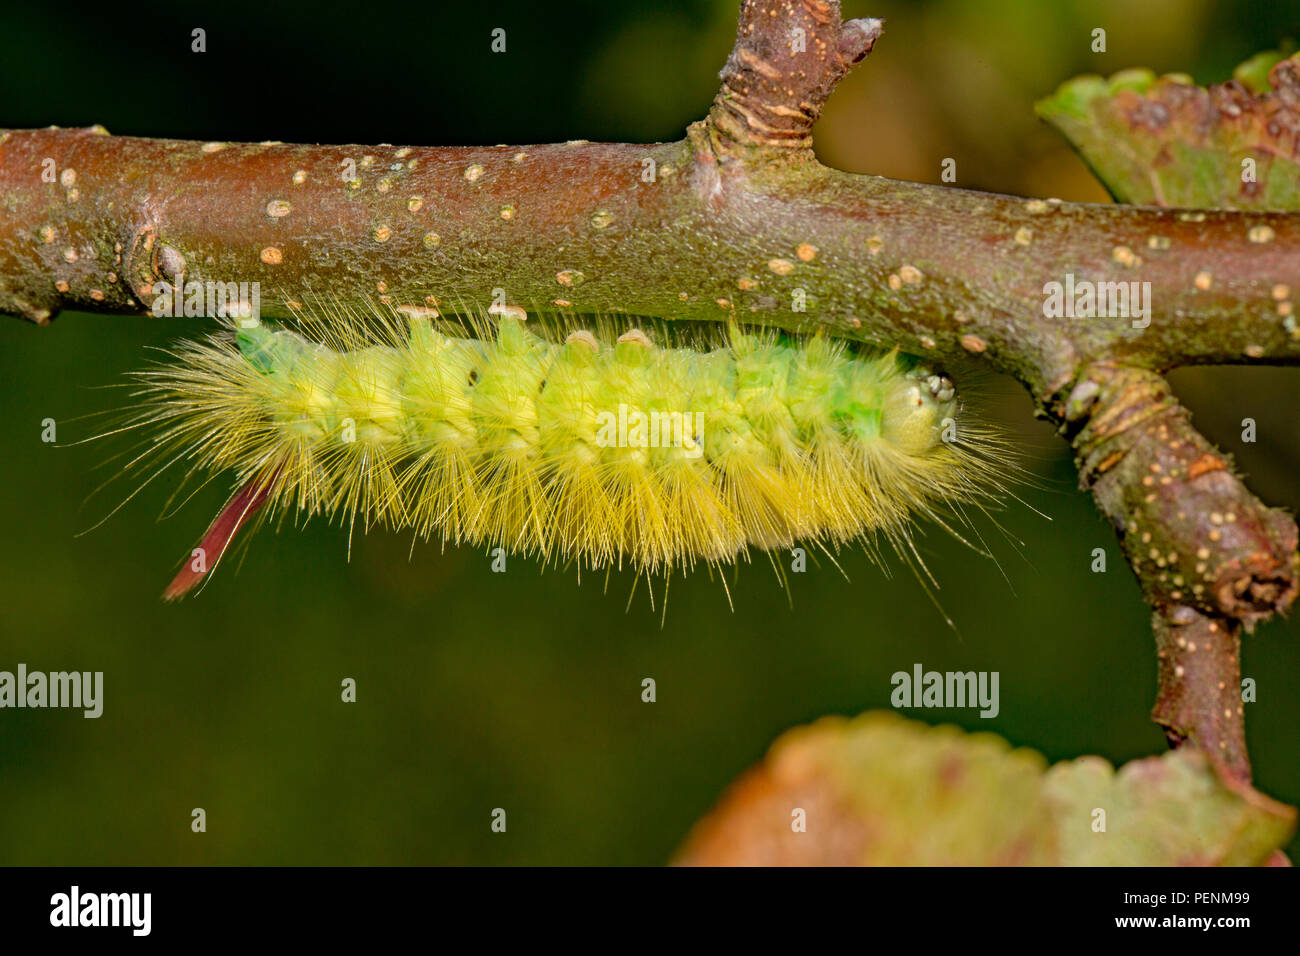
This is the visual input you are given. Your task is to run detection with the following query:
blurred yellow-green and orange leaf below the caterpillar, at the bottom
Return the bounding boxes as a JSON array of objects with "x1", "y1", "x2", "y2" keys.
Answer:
[{"x1": 677, "y1": 711, "x2": 1296, "y2": 866}]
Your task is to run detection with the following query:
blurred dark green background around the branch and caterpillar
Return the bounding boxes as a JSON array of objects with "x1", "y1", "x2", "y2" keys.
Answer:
[{"x1": 0, "y1": 0, "x2": 1300, "y2": 864}]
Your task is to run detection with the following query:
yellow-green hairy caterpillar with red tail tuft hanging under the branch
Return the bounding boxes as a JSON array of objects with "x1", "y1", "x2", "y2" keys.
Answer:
[{"x1": 106, "y1": 310, "x2": 1006, "y2": 600}]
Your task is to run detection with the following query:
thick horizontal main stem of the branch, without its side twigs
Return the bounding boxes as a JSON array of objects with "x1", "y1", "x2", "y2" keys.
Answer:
[{"x1": 0, "y1": 124, "x2": 1300, "y2": 392}]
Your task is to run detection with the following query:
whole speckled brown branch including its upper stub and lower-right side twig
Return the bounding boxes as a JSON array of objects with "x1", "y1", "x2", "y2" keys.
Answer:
[{"x1": 0, "y1": 0, "x2": 1300, "y2": 775}]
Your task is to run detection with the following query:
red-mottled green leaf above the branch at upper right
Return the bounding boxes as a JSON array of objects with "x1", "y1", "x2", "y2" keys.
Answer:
[{"x1": 1036, "y1": 51, "x2": 1300, "y2": 211}]
